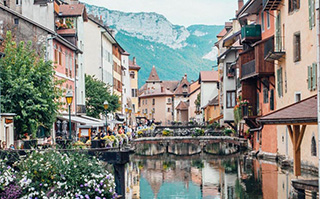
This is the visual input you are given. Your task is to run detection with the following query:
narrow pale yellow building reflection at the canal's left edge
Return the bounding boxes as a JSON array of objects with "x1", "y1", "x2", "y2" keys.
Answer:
[{"x1": 125, "y1": 162, "x2": 140, "y2": 199}]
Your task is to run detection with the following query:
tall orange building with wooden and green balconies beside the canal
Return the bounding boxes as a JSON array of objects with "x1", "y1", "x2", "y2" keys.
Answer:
[{"x1": 237, "y1": 0, "x2": 277, "y2": 157}]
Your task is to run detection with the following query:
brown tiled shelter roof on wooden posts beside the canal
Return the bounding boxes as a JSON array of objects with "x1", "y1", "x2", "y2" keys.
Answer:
[{"x1": 257, "y1": 95, "x2": 318, "y2": 125}]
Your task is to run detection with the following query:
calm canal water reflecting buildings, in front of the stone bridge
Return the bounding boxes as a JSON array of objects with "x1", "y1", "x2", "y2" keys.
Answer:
[{"x1": 125, "y1": 143, "x2": 317, "y2": 199}]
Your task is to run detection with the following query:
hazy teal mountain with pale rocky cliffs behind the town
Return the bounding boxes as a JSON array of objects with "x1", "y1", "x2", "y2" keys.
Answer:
[{"x1": 86, "y1": 4, "x2": 223, "y2": 86}]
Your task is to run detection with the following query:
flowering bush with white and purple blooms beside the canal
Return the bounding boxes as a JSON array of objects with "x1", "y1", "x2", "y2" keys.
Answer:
[{"x1": 0, "y1": 150, "x2": 117, "y2": 199}]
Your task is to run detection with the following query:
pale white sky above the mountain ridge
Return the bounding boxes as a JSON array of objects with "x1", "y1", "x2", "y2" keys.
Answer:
[{"x1": 82, "y1": 0, "x2": 238, "y2": 27}]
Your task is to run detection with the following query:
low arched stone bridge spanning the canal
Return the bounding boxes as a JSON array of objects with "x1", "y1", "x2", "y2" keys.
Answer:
[{"x1": 132, "y1": 136, "x2": 247, "y2": 156}]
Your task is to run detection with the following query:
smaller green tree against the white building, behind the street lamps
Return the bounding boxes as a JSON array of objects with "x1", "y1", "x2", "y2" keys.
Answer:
[{"x1": 85, "y1": 75, "x2": 120, "y2": 118}]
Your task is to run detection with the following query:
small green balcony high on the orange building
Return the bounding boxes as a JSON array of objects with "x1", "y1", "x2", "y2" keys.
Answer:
[{"x1": 241, "y1": 24, "x2": 261, "y2": 43}]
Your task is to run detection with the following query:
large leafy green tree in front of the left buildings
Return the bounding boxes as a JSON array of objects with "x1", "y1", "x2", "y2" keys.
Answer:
[{"x1": 0, "y1": 31, "x2": 62, "y2": 138}]
